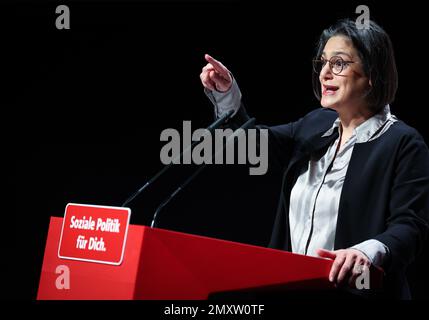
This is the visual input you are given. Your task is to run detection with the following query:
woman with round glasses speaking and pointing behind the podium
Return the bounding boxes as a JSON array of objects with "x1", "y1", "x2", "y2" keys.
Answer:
[{"x1": 200, "y1": 20, "x2": 429, "y2": 298}]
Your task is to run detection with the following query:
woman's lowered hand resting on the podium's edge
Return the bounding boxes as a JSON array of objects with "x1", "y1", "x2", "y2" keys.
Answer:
[{"x1": 317, "y1": 249, "x2": 371, "y2": 287}]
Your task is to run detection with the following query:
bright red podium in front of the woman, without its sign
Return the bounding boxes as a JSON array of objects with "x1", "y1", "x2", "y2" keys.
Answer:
[{"x1": 37, "y1": 217, "x2": 333, "y2": 300}]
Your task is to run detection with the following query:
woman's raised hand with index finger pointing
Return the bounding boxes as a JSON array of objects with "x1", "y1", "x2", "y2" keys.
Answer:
[{"x1": 200, "y1": 54, "x2": 232, "y2": 92}]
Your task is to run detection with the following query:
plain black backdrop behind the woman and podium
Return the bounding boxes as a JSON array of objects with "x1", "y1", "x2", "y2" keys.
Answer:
[{"x1": 5, "y1": 1, "x2": 429, "y2": 299}]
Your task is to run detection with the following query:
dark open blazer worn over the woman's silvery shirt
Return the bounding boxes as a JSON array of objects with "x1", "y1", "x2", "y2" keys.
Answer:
[{"x1": 230, "y1": 106, "x2": 429, "y2": 299}]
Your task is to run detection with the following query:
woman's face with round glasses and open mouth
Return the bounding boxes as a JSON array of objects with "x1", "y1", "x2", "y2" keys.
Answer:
[{"x1": 319, "y1": 36, "x2": 370, "y2": 112}]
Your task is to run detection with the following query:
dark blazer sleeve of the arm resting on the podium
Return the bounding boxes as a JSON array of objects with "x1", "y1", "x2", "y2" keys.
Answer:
[{"x1": 375, "y1": 131, "x2": 429, "y2": 272}]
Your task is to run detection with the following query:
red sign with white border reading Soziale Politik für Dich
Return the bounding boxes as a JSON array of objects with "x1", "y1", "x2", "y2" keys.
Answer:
[{"x1": 58, "y1": 203, "x2": 131, "y2": 265}]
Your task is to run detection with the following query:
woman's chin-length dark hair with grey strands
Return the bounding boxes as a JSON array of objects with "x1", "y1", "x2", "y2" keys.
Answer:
[{"x1": 312, "y1": 19, "x2": 398, "y2": 112}]
